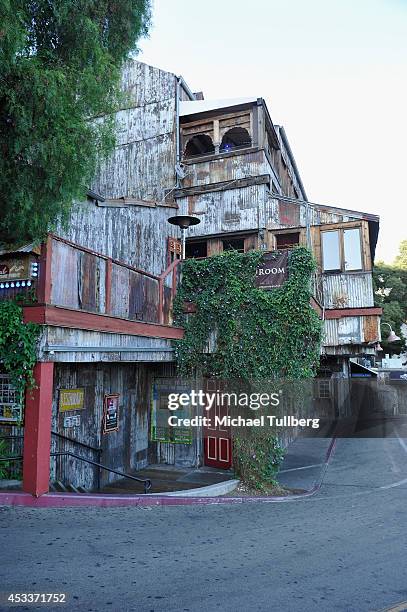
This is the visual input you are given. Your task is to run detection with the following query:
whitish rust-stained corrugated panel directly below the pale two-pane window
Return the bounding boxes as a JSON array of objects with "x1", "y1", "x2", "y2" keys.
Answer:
[{"x1": 322, "y1": 272, "x2": 374, "y2": 308}]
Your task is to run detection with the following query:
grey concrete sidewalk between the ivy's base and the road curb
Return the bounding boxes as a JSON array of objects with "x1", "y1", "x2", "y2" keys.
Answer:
[{"x1": 277, "y1": 437, "x2": 332, "y2": 491}]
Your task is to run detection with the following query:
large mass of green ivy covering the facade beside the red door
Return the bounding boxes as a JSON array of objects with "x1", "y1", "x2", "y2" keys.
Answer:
[{"x1": 174, "y1": 247, "x2": 322, "y2": 491}]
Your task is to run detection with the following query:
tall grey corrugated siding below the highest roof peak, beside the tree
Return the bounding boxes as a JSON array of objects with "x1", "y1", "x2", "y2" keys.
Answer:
[{"x1": 92, "y1": 61, "x2": 176, "y2": 201}]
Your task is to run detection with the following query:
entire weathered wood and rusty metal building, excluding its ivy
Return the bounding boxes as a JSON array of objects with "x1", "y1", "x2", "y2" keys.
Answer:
[{"x1": 0, "y1": 61, "x2": 380, "y2": 495}]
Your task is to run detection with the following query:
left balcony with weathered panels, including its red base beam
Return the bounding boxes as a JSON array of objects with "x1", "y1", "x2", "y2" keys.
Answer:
[{"x1": 0, "y1": 235, "x2": 183, "y2": 338}]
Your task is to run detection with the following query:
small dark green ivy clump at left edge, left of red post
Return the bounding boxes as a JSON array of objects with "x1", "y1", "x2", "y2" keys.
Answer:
[{"x1": 0, "y1": 300, "x2": 41, "y2": 401}]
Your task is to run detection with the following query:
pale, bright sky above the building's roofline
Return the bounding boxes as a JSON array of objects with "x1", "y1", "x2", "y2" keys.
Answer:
[{"x1": 138, "y1": 0, "x2": 407, "y2": 263}]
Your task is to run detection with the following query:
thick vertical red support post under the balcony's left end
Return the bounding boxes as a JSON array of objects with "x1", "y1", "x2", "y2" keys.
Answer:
[{"x1": 23, "y1": 362, "x2": 54, "y2": 497}]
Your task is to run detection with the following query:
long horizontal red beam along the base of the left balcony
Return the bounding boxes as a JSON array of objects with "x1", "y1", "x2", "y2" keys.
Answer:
[{"x1": 24, "y1": 304, "x2": 184, "y2": 340}]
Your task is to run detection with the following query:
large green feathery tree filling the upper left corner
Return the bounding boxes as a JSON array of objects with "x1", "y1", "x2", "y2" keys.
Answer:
[{"x1": 0, "y1": 0, "x2": 150, "y2": 243}]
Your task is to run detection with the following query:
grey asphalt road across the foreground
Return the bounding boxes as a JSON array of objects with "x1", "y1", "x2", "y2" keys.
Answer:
[{"x1": 0, "y1": 438, "x2": 407, "y2": 612}]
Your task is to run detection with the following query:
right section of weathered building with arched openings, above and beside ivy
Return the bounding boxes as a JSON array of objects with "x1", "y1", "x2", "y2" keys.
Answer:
[{"x1": 174, "y1": 98, "x2": 381, "y2": 375}]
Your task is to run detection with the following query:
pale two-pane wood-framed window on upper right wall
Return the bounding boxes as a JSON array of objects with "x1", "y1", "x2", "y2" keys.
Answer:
[{"x1": 321, "y1": 227, "x2": 363, "y2": 272}]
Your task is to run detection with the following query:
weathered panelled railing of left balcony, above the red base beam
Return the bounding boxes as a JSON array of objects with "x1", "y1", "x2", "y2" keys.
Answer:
[{"x1": 0, "y1": 235, "x2": 180, "y2": 325}]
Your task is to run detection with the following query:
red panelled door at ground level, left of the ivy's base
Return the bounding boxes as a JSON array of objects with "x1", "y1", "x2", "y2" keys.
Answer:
[{"x1": 203, "y1": 380, "x2": 232, "y2": 470}]
